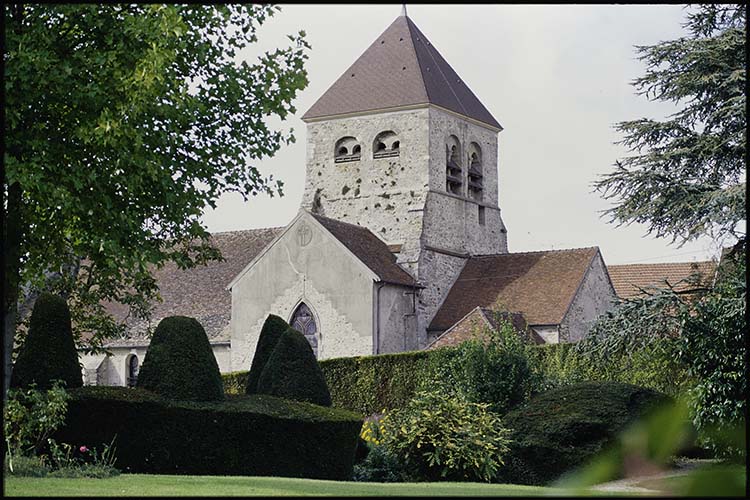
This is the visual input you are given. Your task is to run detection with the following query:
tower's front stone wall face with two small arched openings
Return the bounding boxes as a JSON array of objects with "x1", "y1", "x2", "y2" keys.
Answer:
[{"x1": 302, "y1": 108, "x2": 429, "y2": 271}]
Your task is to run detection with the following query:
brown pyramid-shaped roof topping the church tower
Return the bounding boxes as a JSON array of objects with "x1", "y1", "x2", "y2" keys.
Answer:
[{"x1": 302, "y1": 14, "x2": 502, "y2": 130}]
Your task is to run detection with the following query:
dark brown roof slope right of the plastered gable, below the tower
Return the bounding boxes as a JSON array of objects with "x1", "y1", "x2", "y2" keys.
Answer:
[{"x1": 310, "y1": 213, "x2": 417, "y2": 286}]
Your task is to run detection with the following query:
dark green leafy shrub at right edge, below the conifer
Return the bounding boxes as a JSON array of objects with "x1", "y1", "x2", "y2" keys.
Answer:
[{"x1": 682, "y1": 249, "x2": 747, "y2": 454}]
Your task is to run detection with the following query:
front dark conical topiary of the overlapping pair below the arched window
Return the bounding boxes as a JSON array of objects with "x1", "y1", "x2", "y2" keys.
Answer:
[{"x1": 258, "y1": 328, "x2": 331, "y2": 406}]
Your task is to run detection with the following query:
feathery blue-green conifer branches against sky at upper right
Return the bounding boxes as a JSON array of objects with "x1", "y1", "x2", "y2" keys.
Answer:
[{"x1": 595, "y1": 4, "x2": 747, "y2": 243}]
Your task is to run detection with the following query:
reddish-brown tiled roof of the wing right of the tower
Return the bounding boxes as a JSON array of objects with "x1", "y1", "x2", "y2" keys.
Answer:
[{"x1": 429, "y1": 247, "x2": 599, "y2": 330}]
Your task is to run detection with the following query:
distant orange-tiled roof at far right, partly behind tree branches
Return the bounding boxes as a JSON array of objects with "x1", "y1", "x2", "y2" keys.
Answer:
[{"x1": 607, "y1": 260, "x2": 716, "y2": 299}]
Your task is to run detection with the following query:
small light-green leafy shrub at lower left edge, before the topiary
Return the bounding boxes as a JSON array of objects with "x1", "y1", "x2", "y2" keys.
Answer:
[{"x1": 3, "y1": 383, "x2": 70, "y2": 460}]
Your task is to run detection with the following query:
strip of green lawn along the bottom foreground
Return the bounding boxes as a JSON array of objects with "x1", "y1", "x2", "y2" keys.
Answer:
[{"x1": 3, "y1": 474, "x2": 612, "y2": 496}]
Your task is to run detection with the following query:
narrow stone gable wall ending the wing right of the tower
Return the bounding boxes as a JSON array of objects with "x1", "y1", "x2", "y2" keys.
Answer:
[{"x1": 560, "y1": 253, "x2": 615, "y2": 342}]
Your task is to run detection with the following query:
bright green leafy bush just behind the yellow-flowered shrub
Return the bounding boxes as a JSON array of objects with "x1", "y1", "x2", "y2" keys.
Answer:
[{"x1": 421, "y1": 322, "x2": 538, "y2": 415}]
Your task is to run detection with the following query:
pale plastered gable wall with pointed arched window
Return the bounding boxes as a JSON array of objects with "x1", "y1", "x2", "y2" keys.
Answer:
[{"x1": 226, "y1": 215, "x2": 373, "y2": 370}]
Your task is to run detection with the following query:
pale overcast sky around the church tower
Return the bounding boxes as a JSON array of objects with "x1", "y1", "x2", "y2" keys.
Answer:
[{"x1": 203, "y1": 4, "x2": 736, "y2": 264}]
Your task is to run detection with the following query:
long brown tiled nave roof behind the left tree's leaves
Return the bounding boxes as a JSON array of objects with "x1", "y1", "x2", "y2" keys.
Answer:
[{"x1": 101, "y1": 228, "x2": 282, "y2": 346}]
